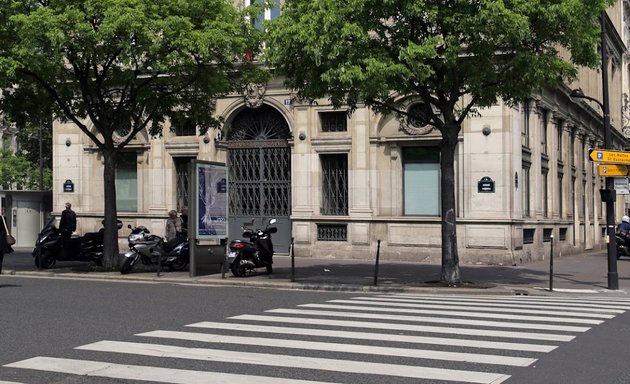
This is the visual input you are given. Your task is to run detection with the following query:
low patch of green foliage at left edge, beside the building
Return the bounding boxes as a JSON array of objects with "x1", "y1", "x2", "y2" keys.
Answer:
[{"x1": 0, "y1": 145, "x2": 52, "y2": 191}]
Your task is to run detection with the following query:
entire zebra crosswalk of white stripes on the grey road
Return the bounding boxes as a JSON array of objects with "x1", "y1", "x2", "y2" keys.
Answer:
[{"x1": 4, "y1": 293, "x2": 630, "y2": 384}]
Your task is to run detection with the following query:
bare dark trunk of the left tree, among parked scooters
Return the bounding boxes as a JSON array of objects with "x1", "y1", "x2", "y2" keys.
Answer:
[{"x1": 103, "y1": 148, "x2": 119, "y2": 268}]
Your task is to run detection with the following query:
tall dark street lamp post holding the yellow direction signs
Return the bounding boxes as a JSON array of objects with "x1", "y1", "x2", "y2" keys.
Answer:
[{"x1": 570, "y1": 11, "x2": 619, "y2": 290}]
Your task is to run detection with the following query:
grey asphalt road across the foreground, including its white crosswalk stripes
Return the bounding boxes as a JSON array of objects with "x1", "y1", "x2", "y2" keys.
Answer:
[{"x1": 0, "y1": 275, "x2": 630, "y2": 384}]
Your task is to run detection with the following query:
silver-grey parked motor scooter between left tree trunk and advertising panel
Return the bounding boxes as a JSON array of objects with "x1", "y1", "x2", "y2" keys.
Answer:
[{"x1": 120, "y1": 225, "x2": 190, "y2": 275}]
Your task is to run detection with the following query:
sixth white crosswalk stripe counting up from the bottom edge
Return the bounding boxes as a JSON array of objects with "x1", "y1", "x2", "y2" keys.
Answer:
[{"x1": 265, "y1": 308, "x2": 590, "y2": 332}]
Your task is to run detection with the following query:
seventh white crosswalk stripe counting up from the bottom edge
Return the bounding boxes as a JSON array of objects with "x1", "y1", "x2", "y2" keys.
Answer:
[{"x1": 299, "y1": 304, "x2": 614, "y2": 325}]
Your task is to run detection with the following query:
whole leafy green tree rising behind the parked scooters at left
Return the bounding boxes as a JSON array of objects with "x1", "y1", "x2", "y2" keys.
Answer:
[{"x1": 0, "y1": 0, "x2": 266, "y2": 266}]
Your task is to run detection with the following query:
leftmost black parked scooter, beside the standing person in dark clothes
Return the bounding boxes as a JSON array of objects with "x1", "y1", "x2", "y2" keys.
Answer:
[{"x1": 32, "y1": 217, "x2": 122, "y2": 269}]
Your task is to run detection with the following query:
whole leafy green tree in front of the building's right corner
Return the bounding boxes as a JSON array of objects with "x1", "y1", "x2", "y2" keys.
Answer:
[{"x1": 267, "y1": 0, "x2": 614, "y2": 285}]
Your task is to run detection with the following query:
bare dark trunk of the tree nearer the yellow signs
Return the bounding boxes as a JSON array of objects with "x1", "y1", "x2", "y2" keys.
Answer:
[{"x1": 440, "y1": 127, "x2": 460, "y2": 286}]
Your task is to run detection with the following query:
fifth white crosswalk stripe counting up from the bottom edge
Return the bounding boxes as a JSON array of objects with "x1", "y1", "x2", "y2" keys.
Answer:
[{"x1": 230, "y1": 315, "x2": 575, "y2": 341}]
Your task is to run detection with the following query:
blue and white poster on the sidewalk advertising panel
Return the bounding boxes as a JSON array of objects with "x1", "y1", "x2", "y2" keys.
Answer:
[{"x1": 194, "y1": 161, "x2": 228, "y2": 240}]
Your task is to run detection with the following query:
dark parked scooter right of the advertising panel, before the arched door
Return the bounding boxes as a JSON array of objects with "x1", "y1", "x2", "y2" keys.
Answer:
[{"x1": 227, "y1": 219, "x2": 278, "y2": 277}]
